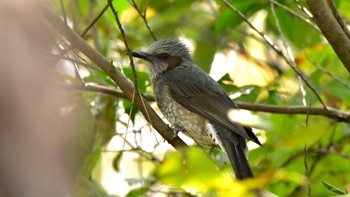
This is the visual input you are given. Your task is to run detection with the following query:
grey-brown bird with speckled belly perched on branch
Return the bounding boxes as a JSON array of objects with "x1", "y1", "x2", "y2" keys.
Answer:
[{"x1": 131, "y1": 38, "x2": 261, "y2": 180}]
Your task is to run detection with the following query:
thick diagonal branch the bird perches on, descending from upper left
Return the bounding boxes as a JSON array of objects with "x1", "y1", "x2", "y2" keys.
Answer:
[{"x1": 45, "y1": 8, "x2": 187, "y2": 149}]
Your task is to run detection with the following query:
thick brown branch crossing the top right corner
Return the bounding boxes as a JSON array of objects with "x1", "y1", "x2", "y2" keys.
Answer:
[{"x1": 307, "y1": 0, "x2": 350, "y2": 73}]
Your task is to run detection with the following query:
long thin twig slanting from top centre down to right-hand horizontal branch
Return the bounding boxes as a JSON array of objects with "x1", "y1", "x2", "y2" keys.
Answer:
[{"x1": 222, "y1": 0, "x2": 328, "y2": 110}]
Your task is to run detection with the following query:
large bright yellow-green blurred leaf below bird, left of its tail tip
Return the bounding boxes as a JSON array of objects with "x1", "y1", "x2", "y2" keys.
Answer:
[{"x1": 156, "y1": 147, "x2": 250, "y2": 196}]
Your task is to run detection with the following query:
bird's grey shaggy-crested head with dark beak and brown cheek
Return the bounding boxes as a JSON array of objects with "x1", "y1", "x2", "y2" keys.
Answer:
[{"x1": 131, "y1": 39, "x2": 192, "y2": 79}]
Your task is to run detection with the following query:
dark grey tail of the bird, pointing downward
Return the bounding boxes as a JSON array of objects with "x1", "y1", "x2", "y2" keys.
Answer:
[{"x1": 221, "y1": 135, "x2": 254, "y2": 180}]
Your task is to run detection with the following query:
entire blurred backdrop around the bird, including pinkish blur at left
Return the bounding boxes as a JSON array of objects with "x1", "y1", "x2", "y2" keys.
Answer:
[{"x1": 0, "y1": 0, "x2": 350, "y2": 197}]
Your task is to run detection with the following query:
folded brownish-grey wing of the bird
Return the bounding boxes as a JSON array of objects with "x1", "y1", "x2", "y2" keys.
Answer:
[{"x1": 166, "y1": 78, "x2": 260, "y2": 144}]
